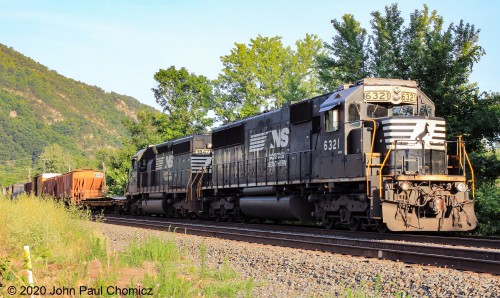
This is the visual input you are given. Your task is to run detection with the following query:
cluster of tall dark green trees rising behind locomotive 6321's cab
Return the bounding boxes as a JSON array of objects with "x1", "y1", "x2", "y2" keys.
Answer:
[{"x1": 318, "y1": 4, "x2": 485, "y2": 149}]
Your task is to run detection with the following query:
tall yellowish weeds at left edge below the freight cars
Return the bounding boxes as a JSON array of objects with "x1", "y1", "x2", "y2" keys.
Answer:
[{"x1": 0, "y1": 195, "x2": 105, "y2": 262}]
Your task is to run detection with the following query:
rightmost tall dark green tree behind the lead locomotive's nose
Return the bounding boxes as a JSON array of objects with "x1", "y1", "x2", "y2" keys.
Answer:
[{"x1": 405, "y1": 6, "x2": 485, "y2": 149}]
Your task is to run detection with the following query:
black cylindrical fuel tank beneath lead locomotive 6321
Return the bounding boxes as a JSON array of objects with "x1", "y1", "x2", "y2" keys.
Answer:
[{"x1": 240, "y1": 196, "x2": 314, "y2": 221}]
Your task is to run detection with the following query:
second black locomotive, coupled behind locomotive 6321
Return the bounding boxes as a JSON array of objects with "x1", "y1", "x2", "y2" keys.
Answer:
[{"x1": 126, "y1": 134, "x2": 212, "y2": 216}]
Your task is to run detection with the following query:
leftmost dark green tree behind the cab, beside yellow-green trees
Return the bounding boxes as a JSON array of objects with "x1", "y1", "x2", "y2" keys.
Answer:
[{"x1": 317, "y1": 14, "x2": 369, "y2": 91}]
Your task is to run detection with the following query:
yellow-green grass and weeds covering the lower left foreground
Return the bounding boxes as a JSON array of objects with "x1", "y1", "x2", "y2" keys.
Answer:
[{"x1": 0, "y1": 196, "x2": 254, "y2": 297}]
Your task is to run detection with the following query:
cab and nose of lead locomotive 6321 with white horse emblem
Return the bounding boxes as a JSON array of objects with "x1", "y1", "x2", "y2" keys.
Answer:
[{"x1": 320, "y1": 78, "x2": 477, "y2": 231}]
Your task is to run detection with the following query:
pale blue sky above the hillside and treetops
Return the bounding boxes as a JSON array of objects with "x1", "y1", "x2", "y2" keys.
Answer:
[{"x1": 0, "y1": 0, "x2": 500, "y2": 109}]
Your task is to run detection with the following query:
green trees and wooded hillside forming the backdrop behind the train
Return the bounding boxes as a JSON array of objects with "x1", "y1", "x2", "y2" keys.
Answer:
[{"x1": 0, "y1": 4, "x2": 500, "y2": 234}]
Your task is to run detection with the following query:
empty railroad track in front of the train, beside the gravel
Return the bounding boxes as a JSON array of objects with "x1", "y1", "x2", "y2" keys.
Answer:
[{"x1": 96, "y1": 215, "x2": 500, "y2": 274}]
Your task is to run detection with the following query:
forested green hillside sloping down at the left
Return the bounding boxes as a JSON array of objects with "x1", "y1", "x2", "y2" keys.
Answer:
[{"x1": 0, "y1": 44, "x2": 152, "y2": 185}]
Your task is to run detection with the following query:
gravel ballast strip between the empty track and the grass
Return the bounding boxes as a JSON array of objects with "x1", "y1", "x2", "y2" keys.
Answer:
[{"x1": 92, "y1": 223, "x2": 500, "y2": 297}]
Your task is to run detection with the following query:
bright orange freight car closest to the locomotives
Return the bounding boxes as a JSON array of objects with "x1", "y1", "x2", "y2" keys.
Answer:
[{"x1": 51, "y1": 170, "x2": 106, "y2": 204}]
